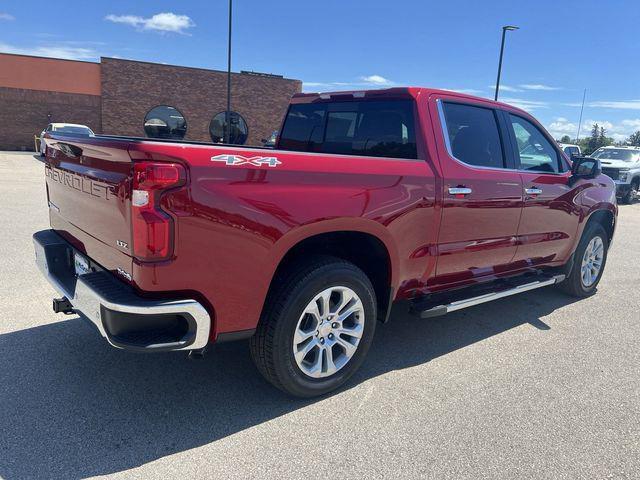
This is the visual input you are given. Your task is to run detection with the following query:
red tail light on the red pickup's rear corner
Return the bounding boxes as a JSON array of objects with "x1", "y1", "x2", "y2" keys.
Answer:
[{"x1": 131, "y1": 162, "x2": 186, "y2": 261}]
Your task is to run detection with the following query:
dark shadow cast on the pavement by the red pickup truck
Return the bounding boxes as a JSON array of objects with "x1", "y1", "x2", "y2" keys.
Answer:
[{"x1": 0, "y1": 288, "x2": 573, "y2": 479}]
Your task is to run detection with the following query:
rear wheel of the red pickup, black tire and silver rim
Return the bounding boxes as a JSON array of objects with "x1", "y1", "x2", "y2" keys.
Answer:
[{"x1": 250, "y1": 256, "x2": 376, "y2": 398}]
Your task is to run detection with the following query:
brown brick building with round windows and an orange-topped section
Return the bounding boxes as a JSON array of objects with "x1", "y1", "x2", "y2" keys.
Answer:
[{"x1": 0, "y1": 53, "x2": 302, "y2": 150}]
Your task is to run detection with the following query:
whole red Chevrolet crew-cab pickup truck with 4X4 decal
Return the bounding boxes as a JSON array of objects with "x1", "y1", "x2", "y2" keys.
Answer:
[{"x1": 34, "y1": 88, "x2": 617, "y2": 396}]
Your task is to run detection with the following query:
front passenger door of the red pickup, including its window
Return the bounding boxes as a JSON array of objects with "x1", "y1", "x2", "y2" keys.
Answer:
[{"x1": 504, "y1": 112, "x2": 579, "y2": 266}]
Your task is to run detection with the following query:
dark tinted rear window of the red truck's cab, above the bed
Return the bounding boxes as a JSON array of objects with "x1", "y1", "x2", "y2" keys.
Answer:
[{"x1": 278, "y1": 99, "x2": 417, "y2": 159}]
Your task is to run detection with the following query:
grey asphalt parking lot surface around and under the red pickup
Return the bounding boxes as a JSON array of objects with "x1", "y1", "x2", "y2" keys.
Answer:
[{"x1": 0, "y1": 152, "x2": 640, "y2": 479}]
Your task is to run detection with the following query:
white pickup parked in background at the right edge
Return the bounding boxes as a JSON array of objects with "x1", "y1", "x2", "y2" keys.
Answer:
[{"x1": 591, "y1": 143, "x2": 640, "y2": 203}]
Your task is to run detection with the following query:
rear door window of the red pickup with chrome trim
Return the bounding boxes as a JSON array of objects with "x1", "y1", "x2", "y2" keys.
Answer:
[{"x1": 443, "y1": 102, "x2": 505, "y2": 168}]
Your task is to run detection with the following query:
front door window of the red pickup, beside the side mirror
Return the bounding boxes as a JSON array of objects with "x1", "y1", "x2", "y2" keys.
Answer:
[{"x1": 509, "y1": 114, "x2": 560, "y2": 173}]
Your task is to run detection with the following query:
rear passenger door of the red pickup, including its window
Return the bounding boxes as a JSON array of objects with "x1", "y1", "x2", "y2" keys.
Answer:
[{"x1": 429, "y1": 95, "x2": 523, "y2": 286}]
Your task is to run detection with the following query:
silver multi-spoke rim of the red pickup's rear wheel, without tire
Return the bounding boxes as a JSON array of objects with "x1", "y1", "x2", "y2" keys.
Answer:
[{"x1": 293, "y1": 286, "x2": 365, "y2": 378}]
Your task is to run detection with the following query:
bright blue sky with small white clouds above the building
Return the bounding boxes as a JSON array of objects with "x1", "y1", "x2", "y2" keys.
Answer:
[{"x1": 0, "y1": 0, "x2": 640, "y2": 140}]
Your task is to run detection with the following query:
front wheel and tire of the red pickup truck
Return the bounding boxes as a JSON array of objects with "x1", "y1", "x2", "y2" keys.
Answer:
[{"x1": 559, "y1": 223, "x2": 609, "y2": 298}]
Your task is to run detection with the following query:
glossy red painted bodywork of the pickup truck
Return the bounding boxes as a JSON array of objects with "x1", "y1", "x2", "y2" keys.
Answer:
[{"x1": 42, "y1": 89, "x2": 617, "y2": 339}]
